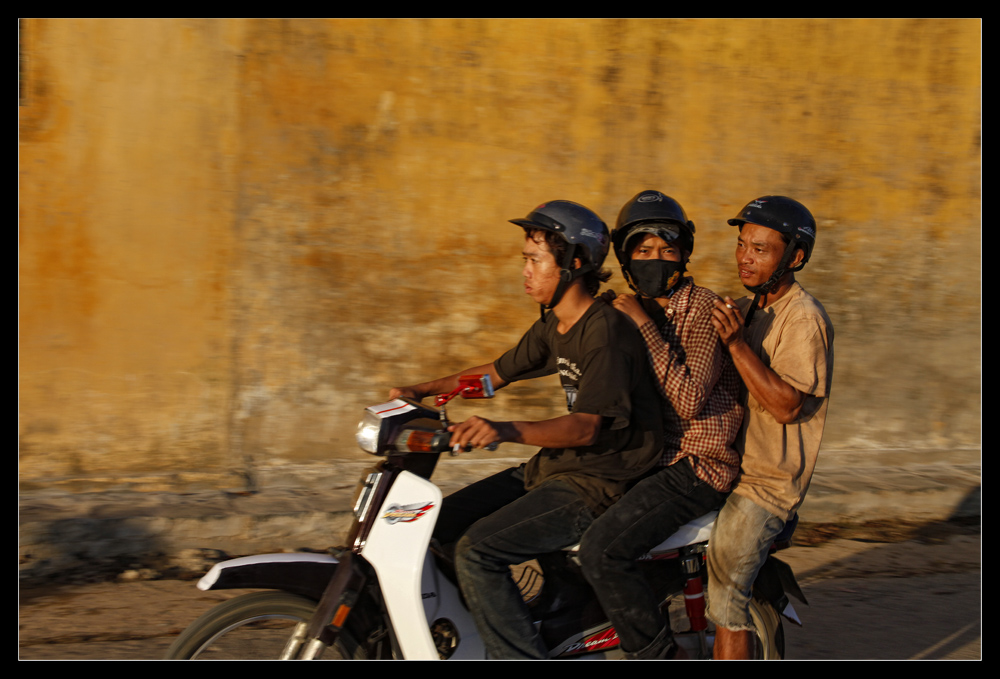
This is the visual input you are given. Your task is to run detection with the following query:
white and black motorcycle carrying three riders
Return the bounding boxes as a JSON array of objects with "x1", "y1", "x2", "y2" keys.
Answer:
[{"x1": 166, "y1": 375, "x2": 806, "y2": 660}]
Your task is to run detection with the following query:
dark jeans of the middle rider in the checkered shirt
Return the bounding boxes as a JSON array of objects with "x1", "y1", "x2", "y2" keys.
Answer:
[{"x1": 580, "y1": 460, "x2": 726, "y2": 658}]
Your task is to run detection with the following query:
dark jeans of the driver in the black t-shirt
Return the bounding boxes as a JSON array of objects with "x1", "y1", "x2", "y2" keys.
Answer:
[{"x1": 434, "y1": 467, "x2": 594, "y2": 659}]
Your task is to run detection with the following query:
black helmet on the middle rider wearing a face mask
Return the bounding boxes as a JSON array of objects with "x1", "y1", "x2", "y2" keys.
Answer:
[{"x1": 611, "y1": 190, "x2": 694, "y2": 267}]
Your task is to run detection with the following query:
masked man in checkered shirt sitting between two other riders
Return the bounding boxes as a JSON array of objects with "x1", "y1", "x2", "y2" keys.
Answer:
[{"x1": 580, "y1": 190, "x2": 743, "y2": 659}]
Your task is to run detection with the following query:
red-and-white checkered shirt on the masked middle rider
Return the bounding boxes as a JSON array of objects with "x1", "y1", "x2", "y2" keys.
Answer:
[{"x1": 639, "y1": 278, "x2": 743, "y2": 492}]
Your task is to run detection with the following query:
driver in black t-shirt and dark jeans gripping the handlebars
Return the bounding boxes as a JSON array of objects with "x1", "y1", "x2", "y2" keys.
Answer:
[{"x1": 390, "y1": 201, "x2": 663, "y2": 658}]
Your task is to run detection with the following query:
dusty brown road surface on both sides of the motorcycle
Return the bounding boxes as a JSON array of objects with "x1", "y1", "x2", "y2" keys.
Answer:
[{"x1": 18, "y1": 525, "x2": 982, "y2": 660}]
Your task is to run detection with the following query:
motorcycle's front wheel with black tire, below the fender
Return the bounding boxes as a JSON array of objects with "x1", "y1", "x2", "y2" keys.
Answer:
[{"x1": 166, "y1": 592, "x2": 365, "y2": 660}]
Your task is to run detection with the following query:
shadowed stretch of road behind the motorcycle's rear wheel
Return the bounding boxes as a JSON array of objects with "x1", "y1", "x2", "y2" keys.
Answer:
[{"x1": 785, "y1": 535, "x2": 982, "y2": 660}]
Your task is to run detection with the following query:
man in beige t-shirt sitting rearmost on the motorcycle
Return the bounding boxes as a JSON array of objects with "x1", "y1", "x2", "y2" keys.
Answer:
[{"x1": 708, "y1": 196, "x2": 833, "y2": 658}]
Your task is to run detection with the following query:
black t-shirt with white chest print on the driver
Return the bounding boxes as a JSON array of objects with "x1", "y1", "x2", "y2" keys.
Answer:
[{"x1": 493, "y1": 300, "x2": 663, "y2": 513}]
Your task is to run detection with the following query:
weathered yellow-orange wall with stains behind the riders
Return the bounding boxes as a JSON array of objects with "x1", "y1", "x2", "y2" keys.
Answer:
[{"x1": 19, "y1": 20, "x2": 982, "y2": 488}]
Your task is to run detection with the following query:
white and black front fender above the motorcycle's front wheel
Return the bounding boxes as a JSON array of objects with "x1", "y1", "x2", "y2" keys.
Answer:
[{"x1": 198, "y1": 552, "x2": 341, "y2": 601}]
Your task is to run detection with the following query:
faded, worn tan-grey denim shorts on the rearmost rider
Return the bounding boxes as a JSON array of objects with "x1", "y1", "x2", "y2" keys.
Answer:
[{"x1": 708, "y1": 493, "x2": 785, "y2": 631}]
